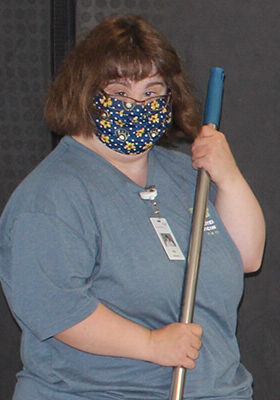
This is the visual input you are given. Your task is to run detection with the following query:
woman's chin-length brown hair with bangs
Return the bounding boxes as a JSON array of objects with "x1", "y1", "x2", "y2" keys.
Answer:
[{"x1": 45, "y1": 15, "x2": 201, "y2": 140}]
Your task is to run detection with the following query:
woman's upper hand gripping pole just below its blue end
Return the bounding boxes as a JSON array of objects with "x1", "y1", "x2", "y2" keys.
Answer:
[{"x1": 192, "y1": 125, "x2": 240, "y2": 187}]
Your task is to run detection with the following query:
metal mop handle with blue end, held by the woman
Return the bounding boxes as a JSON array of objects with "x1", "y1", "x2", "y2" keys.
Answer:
[{"x1": 169, "y1": 67, "x2": 224, "y2": 400}]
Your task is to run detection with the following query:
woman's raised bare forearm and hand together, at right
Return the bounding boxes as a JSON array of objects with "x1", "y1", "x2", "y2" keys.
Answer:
[{"x1": 192, "y1": 125, "x2": 265, "y2": 272}]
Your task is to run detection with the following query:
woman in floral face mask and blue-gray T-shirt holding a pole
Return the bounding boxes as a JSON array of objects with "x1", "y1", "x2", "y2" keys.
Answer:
[{"x1": 1, "y1": 16, "x2": 265, "y2": 400}]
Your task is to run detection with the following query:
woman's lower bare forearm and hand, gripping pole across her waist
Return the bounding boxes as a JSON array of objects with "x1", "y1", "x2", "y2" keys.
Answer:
[{"x1": 55, "y1": 303, "x2": 202, "y2": 369}]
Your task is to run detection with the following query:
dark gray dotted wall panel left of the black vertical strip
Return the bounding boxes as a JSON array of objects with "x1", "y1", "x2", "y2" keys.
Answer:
[{"x1": 0, "y1": 0, "x2": 51, "y2": 400}]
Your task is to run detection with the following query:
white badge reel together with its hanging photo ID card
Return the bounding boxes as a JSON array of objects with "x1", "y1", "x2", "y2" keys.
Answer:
[{"x1": 139, "y1": 186, "x2": 185, "y2": 260}]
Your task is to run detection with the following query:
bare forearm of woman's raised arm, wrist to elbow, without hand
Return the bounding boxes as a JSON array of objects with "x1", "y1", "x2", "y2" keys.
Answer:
[{"x1": 215, "y1": 170, "x2": 265, "y2": 272}]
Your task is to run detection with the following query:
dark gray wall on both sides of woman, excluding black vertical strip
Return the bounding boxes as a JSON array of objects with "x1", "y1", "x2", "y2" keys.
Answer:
[{"x1": 0, "y1": 0, "x2": 280, "y2": 400}]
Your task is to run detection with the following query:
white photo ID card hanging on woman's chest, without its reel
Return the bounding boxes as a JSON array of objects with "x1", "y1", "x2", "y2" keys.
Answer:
[{"x1": 150, "y1": 217, "x2": 185, "y2": 260}]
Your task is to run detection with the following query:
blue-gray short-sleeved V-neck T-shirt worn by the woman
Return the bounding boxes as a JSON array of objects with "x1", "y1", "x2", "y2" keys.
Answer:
[{"x1": 0, "y1": 137, "x2": 252, "y2": 400}]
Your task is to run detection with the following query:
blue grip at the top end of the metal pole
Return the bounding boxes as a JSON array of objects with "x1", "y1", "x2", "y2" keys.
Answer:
[{"x1": 203, "y1": 67, "x2": 225, "y2": 127}]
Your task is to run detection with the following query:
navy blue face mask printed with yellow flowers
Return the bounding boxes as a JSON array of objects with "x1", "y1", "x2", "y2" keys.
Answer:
[{"x1": 92, "y1": 93, "x2": 171, "y2": 154}]
